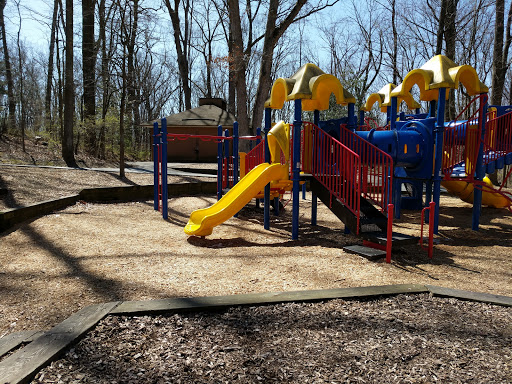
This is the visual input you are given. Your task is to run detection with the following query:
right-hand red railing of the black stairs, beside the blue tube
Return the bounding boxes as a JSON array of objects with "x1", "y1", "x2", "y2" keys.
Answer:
[{"x1": 340, "y1": 126, "x2": 393, "y2": 212}]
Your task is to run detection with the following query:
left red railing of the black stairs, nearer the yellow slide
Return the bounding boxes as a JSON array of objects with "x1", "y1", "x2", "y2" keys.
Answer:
[{"x1": 308, "y1": 126, "x2": 361, "y2": 228}]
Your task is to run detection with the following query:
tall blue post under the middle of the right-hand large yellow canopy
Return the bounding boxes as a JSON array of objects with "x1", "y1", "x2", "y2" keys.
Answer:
[{"x1": 433, "y1": 88, "x2": 446, "y2": 234}]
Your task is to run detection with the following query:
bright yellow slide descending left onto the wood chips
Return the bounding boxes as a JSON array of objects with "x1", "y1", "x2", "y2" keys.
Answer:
[{"x1": 184, "y1": 163, "x2": 288, "y2": 236}]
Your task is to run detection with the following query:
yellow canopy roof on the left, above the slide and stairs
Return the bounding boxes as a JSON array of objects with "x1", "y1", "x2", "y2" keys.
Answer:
[{"x1": 265, "y1": 63, "x2": 356, "y2": 111}]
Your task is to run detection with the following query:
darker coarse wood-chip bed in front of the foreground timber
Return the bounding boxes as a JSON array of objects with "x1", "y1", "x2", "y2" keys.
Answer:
[{"x1": 34, "y1": 294, "x2": 512, "y2": 383}]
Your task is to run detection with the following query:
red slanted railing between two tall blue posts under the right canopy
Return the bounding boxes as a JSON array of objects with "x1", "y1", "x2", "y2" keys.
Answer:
[{"x1": 441, "y1": 95, "x2": 487, "y2": 180}]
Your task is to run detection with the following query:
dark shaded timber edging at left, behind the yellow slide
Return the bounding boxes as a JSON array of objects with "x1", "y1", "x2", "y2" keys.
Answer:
[{"x1": 0, "y1": 181, "x2": 217, "y2": 232}]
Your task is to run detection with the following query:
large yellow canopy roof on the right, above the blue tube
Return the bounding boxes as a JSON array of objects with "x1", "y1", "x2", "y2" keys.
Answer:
[{"x1": 391, "y1": 55, "x2": 489, "y2": 101}]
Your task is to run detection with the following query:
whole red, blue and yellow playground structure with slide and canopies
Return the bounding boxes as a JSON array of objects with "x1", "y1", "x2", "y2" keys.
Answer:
[{"x1": 154, "y1": 55, "x2": 512, "y2": 261}]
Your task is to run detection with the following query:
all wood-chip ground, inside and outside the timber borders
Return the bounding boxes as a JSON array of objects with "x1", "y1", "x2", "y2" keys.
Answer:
[{"x1": 0, "y1": 166, "x2": 512, "y2": 383}]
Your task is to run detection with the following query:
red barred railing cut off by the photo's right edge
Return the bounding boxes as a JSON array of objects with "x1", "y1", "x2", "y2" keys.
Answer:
[{"x1": 484, "y1": 112, "x2": 512, "y2": 164}]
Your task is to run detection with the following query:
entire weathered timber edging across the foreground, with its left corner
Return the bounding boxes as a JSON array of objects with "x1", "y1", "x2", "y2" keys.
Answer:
[{"x1": 0, "y1": 284, "x2": 512, "y2": 384}]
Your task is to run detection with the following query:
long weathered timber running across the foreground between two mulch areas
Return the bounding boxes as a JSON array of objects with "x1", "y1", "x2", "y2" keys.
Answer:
[{"x1": 111, "y1": 284, "x2": 428, "y2": 315}]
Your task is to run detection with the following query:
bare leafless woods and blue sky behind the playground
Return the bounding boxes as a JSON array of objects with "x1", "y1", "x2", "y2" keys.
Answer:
[{"x1": 0, "y1": 0, "x2": 512, "y2": 172}]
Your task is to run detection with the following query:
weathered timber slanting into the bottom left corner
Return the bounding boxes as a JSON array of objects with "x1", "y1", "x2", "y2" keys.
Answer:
[{"x1": 0, "y1": 302, "x2": 119, "y2": 384}]
